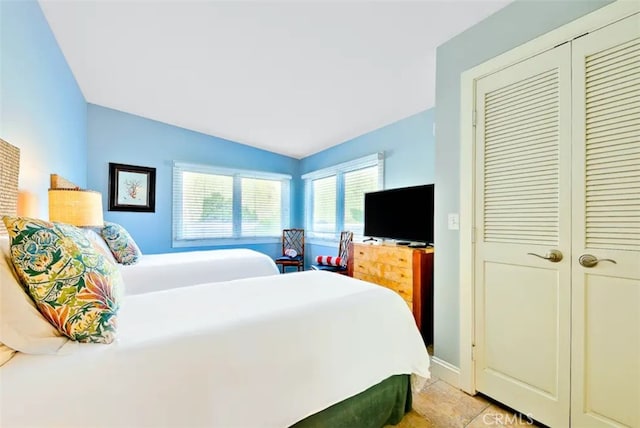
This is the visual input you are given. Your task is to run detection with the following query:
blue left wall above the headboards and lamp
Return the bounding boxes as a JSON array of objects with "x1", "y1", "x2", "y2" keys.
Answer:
[{"x1": 0, "y1": 0, "x2": 87, "y2": 218}]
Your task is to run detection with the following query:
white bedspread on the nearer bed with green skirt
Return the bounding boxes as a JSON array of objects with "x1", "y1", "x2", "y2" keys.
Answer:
[{"x1": 0, "y1": 271, "x2": 429, "y2": 427}]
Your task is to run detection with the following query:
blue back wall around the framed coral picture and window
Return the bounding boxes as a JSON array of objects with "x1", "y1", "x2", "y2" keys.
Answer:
[{"x1": 87, "y1": 104, "x2": 300, "y2": 256}]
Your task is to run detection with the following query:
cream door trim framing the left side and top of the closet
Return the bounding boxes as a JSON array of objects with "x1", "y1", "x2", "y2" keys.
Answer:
[{"x1": 457, "y1": 0, "x2": 640, "y2": 394}]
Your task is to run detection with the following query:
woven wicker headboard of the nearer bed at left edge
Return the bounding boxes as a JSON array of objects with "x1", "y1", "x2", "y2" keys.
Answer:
[{"x1": 0, "y1": 139, "x2": 20, "y2": 235}]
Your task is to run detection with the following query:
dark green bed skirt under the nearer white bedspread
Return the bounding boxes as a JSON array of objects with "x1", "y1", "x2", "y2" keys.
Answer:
[{"x1": 292, "y1": 375, "x2": 411, "y2": 428}]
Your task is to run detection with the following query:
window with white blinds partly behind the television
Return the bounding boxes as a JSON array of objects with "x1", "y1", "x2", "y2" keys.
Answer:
[{"x1": 302, "y1": 153, "x2": 384, "y2": 239}]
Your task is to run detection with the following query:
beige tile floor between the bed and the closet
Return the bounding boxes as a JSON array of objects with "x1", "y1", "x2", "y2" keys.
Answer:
[{"x1": 387, "y1": 378, "x2": 541, "y2": 428}]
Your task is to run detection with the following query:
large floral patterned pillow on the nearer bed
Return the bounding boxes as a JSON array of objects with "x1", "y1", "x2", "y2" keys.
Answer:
[{"x1": 3, "y1": 217, "x2": 123, "y2": 343}]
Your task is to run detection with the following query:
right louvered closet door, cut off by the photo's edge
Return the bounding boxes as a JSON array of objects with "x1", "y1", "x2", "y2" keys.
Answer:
[{"x1": 571, "y1": 14, "x2": 640, "y2": 427}]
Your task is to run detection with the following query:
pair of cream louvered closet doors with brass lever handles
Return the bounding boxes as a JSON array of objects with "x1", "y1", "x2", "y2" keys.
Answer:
[{"x1": 474, "y1": 14, "x2": 640, "y2": 427}]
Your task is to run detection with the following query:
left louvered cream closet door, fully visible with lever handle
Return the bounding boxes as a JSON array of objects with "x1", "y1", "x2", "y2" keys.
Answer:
[{"x1": 474, "y1": 44, "x2": 571, "y2": 427}]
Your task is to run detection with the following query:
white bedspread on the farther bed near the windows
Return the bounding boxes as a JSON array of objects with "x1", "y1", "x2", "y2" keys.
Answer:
[{"x1": 119, "y1": 249, "x2": 279, "y2": 294}]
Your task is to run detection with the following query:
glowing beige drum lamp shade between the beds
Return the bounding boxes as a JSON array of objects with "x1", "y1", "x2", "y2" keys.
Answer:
[{"x1": 49, "y1": 189, "x2": 104, "y2": 227}]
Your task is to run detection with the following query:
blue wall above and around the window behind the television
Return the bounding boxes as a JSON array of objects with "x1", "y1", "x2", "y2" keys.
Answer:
[{"x1": 298, "y1": 109, "x2": 435, "y2": 265}]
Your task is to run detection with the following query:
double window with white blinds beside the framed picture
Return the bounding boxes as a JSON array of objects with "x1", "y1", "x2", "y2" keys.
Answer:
[{"x1": 173, "y1": 163, "x2": 291, "y2": 246}]
